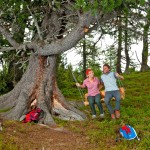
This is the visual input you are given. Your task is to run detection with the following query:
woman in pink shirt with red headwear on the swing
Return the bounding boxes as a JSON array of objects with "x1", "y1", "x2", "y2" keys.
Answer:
[{"x1": 76, "y1": 68, "x2": 104, "y2": 118}]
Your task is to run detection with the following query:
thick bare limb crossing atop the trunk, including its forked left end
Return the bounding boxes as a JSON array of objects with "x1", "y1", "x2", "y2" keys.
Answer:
[{"x1": 0, "y1": 9, "x2": 117, "y2": 56}]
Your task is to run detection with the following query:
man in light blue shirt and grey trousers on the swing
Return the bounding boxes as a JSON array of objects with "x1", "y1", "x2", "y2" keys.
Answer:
[{"x1": 101, "y1": 64, "x2": 124, "y2": 119}]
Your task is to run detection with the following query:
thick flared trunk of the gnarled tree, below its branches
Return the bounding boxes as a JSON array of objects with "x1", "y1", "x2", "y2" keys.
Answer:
[{"x1": 0, "y1": 55, "x2": 86, "y2": 124}]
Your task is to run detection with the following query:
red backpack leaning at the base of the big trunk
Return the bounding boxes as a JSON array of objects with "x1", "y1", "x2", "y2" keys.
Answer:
[{"x1": 23, "y1": 108, "x2": 43, "y2": 123}]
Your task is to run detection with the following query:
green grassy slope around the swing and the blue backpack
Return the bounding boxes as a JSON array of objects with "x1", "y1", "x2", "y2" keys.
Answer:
[{"x1": 61, "y1": 71, "x2": 150, "y2": 150}]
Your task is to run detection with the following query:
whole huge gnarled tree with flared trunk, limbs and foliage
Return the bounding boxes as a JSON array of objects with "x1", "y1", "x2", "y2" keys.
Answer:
[{"x1": 0, "y1": 0, "x2": 142, "y2": 124}]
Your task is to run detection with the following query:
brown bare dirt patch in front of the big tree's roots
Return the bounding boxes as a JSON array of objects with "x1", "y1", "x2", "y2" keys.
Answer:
[{"x1": 1, "y1": 121, "x2": 93, "y2": 150}]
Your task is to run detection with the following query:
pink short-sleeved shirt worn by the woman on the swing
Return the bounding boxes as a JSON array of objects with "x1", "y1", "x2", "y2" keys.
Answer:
[{"x1": 82, "y1": 77, "x2": 100, "y2": 96}]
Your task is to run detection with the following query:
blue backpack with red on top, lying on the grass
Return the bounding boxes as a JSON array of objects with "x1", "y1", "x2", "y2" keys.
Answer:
[{"x1": 116, "y1": 125, "x2": 140, "y2": 142}]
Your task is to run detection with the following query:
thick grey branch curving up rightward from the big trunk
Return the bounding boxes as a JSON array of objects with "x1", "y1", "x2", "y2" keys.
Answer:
[{"x1": 37, "y1": 12, "x2": 117, "y2": 56}]
